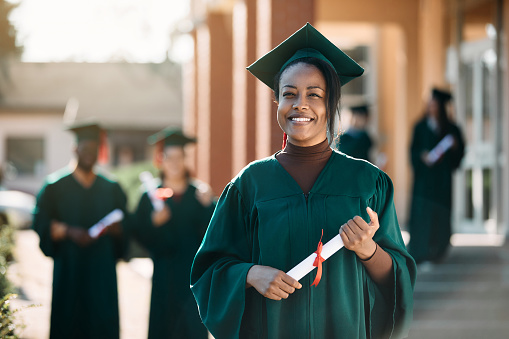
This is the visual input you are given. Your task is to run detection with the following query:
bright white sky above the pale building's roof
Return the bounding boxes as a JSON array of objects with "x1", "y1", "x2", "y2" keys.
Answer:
[{"x1": 9, "y1": 0, "x2": 189, "y2": 62}]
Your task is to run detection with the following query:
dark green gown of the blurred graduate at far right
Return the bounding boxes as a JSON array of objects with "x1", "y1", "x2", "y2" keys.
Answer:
[{"x1": 408, "y1": 118, "x2": 465, "y2": 263}]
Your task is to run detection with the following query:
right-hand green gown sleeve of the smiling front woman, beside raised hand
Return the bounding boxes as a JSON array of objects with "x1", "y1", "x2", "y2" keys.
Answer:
[{"x1": 367, "y1": 172, "x2": 416, "y2": 338}]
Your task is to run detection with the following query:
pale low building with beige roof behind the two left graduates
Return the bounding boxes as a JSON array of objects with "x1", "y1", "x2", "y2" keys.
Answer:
[{"x1": 0, "y1": 60, "x2": 182, "y2": 194}]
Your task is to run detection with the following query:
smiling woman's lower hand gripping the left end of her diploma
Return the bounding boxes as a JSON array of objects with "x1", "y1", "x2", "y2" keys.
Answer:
[{"x1": 246, "y1": 265, "x2": 302, "y2": 300}]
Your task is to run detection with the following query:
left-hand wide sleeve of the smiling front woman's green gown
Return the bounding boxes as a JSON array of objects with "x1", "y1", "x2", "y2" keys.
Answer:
[{"x1": 191, "y1": 183, "x2": 254, "y2": 338}]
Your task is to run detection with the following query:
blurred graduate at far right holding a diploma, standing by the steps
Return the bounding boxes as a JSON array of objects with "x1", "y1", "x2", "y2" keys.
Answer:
[{"x1": 408, "y1": 88, "x2": 465, "y2": 263}]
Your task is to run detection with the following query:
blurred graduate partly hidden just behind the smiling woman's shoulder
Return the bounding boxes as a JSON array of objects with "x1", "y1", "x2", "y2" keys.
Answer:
[{"x1": 338, "y1": 105, "x2": 373, "y2": 161}]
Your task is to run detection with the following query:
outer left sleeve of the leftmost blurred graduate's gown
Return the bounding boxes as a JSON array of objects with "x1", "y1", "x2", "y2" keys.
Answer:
[{"x1": 32, "y1": 183, "x2": 57, "y2": 257}]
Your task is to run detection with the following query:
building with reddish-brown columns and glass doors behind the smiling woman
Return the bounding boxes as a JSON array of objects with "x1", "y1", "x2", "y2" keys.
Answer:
[{"x1": 183, "y1": 0, "x2": 509, "y2": 239}]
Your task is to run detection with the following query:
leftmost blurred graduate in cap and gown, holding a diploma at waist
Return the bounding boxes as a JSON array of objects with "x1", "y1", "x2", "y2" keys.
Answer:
[{"x1": 32, "y1": 123, "x2": 127, "y2": 339}]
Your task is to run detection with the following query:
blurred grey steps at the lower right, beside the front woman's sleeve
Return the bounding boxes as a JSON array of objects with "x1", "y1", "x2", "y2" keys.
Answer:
[{"x1": 409, "y1": 236, "x2": 509, "y2": 339}]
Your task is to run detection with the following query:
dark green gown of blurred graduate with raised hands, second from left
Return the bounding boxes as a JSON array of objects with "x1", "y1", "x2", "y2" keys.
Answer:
[{"x1": 133, "y1": 184, "x2": 214, "y2": 339}]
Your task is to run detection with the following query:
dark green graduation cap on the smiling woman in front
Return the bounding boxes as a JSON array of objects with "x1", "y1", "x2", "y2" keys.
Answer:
[{"x1": 247, "y1": 22, "x2": 364, "y2": 90}]
